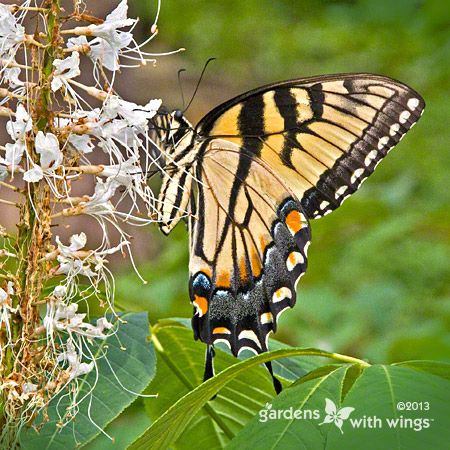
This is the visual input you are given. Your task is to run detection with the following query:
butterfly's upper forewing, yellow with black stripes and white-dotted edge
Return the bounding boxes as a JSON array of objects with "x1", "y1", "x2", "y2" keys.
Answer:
[{"x1": 196, "y1": 74, "x2": 424, "y2": 218}]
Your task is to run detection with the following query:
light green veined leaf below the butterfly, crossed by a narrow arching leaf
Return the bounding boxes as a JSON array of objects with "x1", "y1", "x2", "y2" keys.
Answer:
[{"x1": 145, "y1": 322, "x2": 275, "y2": 449}]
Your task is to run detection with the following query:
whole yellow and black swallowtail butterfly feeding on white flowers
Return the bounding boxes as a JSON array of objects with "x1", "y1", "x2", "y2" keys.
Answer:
[{"x1": 155, "y1": 74, "x2": 425, "y2": 390}]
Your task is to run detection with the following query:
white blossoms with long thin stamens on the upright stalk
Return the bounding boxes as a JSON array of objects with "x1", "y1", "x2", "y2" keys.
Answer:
[{"x1": 0, "y1": 0, "x2": 174, "y2": 426}]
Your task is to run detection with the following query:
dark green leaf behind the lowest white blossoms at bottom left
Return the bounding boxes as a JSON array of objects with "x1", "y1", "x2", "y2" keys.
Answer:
[{"x1": 21, "y1": 313, "x2": 156, "y2": 450}]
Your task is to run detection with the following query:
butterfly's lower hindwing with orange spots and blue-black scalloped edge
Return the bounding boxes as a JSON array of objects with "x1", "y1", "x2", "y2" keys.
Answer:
[{"x1": 190, "y1": 139, "x2": 310, "y2": 354}]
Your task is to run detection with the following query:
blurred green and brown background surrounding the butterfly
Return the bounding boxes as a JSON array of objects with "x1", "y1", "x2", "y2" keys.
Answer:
[{"x1": 117, "y1": 0, "x2": 450, "y2": 362}]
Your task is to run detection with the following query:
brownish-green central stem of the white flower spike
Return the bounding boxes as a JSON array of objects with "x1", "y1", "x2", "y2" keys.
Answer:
[{"x1": 0, "y1": 0, "x2": 60, "y2": 428}]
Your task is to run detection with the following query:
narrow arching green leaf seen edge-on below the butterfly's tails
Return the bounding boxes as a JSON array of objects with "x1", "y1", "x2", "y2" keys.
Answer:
[{"x1": 129, "y1": 346, "x2": 366, "y2": 450}]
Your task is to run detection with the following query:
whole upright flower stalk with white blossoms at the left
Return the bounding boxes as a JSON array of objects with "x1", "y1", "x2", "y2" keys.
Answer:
[{"x1": 0, "y1": 0, "x2": 179, "y2": 442}]
